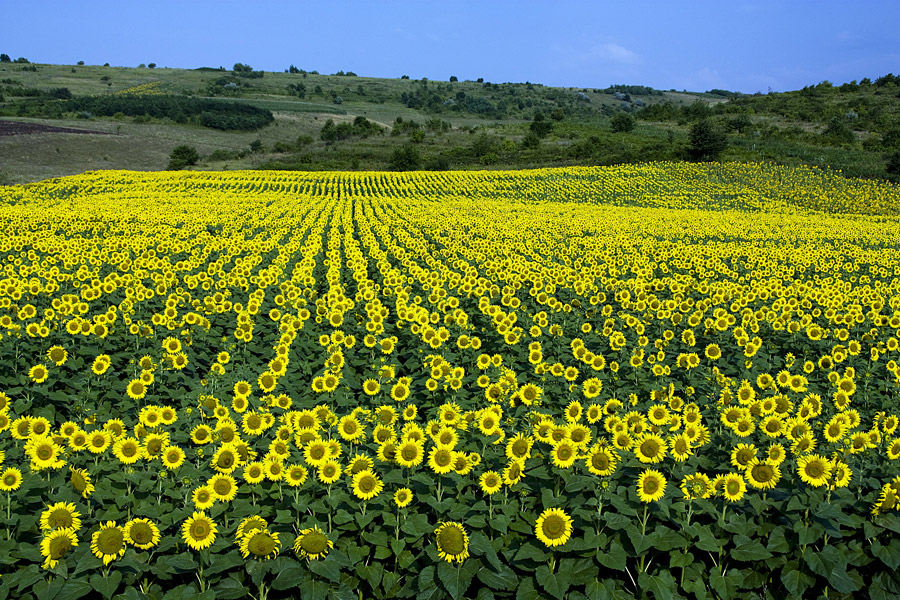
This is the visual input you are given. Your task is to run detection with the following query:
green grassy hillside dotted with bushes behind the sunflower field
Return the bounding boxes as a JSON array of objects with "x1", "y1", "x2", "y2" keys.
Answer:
[{"x1": 0, "y1": 63, "x2": 900, "y2": 183}]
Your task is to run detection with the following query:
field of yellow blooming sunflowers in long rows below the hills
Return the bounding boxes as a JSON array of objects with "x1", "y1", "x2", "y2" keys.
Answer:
[{"x1": 0, "y1": 163, "x2": 900, "y2": 600}]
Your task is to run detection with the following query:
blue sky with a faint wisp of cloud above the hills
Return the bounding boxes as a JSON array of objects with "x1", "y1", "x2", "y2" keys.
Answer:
[{"x1": 0, "y1": 0, "x2": 900, "y2": 93}]
